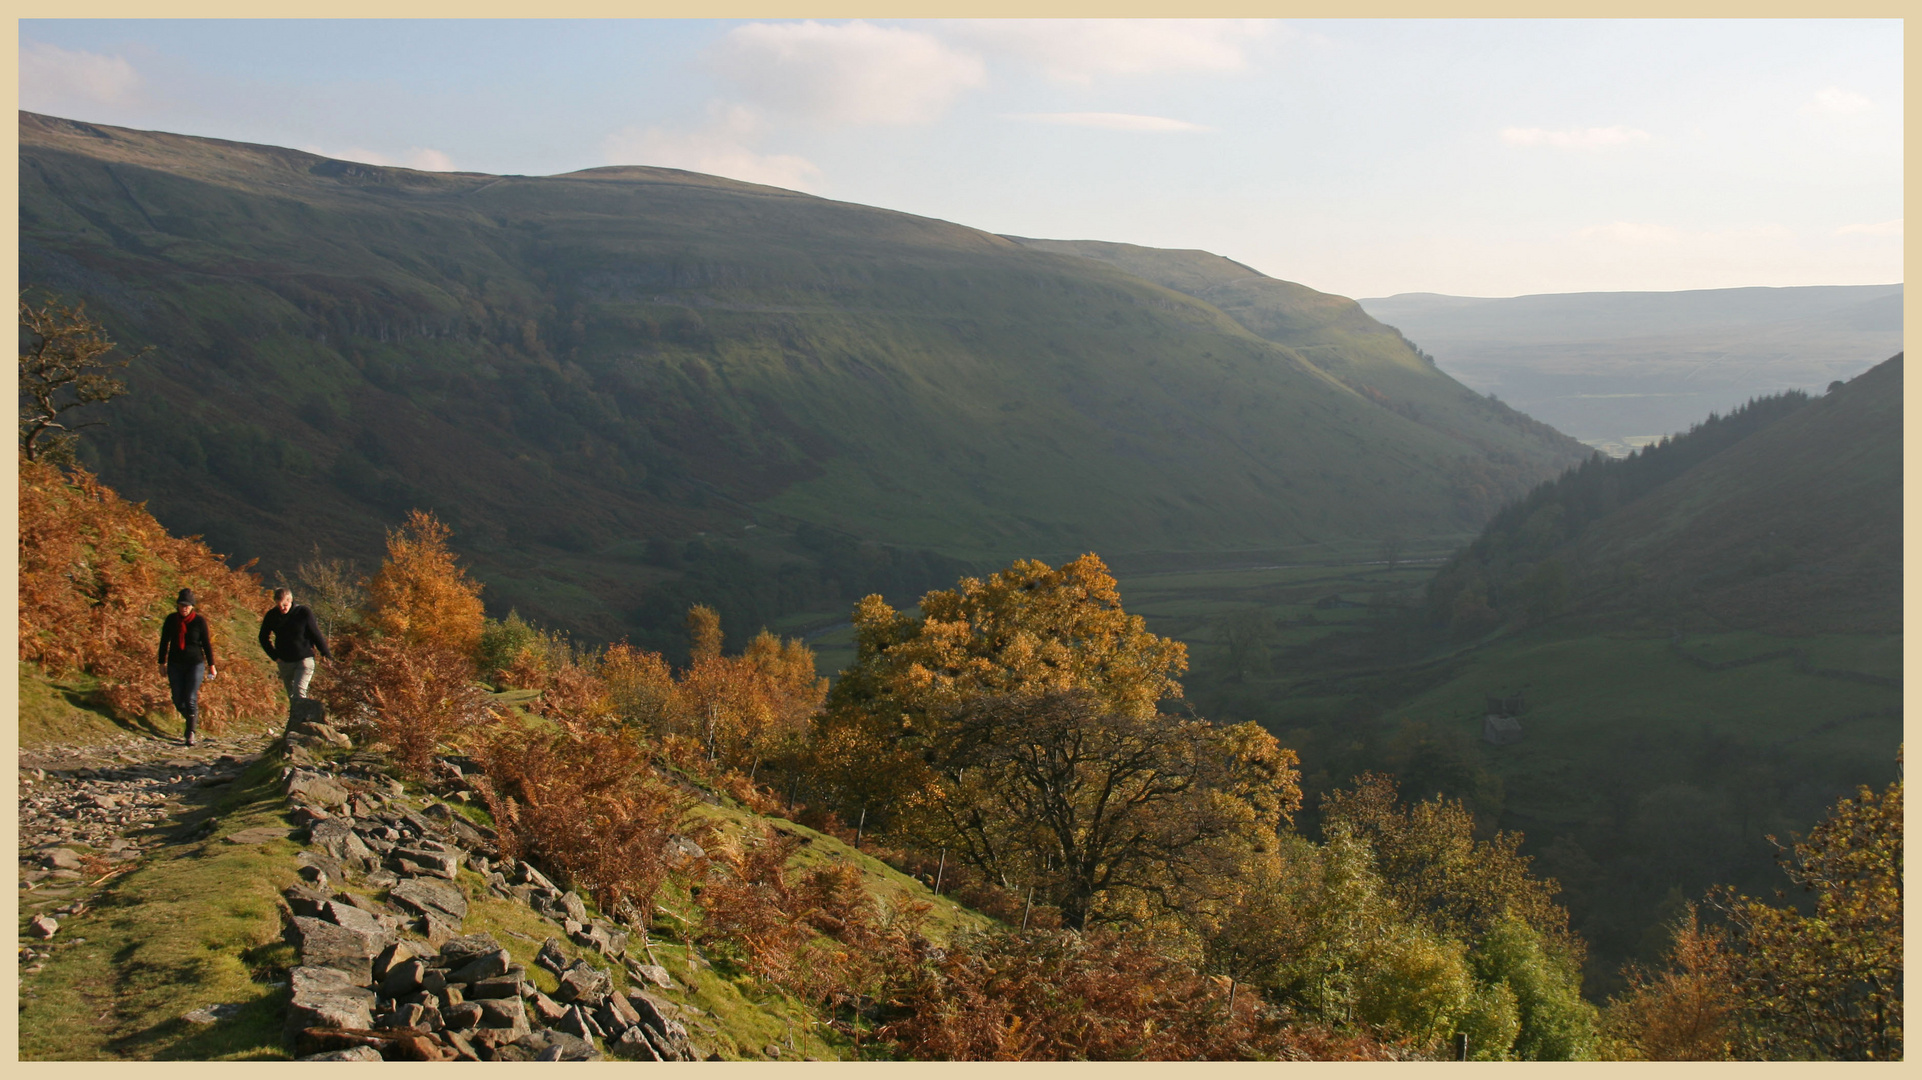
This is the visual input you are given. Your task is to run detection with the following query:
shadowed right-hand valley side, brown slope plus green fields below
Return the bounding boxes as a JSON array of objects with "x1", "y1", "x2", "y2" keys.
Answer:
[{"x1": 1168, "y1": 357, "x2": 1903, "y2": 994}]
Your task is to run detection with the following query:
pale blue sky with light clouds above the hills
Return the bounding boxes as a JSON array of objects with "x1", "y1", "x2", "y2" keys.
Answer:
[{"x1": 19, "y1": 19, "x2": 1903, "y2": 298}]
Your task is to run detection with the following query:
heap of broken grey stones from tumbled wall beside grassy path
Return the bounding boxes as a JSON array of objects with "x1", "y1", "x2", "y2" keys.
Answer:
[{"x1": 267, "y1": 723, "x2": 707, "y2": 1061}]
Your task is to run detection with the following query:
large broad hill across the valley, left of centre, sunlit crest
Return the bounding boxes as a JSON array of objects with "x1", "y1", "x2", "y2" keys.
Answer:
[{"x1": 19, "y1": 113, "x2": 1578, "y2": 638}]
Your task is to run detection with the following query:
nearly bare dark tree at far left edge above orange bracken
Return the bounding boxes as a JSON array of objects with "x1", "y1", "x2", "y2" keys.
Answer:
[{"x1": 19, "y1": 296, "x2": 150, "y2": 465}]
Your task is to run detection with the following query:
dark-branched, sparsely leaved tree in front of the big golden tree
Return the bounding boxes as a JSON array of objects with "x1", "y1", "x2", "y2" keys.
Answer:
[{"x1": 901, "y1": 690, "x2": 1301, "y2": 930}]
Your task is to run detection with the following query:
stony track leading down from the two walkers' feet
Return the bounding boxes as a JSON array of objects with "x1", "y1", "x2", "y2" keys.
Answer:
[{"x1": 19, "y1": 734, "x2": 265, "y2": 968}]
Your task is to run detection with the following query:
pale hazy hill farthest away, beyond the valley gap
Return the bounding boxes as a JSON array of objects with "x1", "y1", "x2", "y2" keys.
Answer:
[{"x1": 1359, "y1": 284, "x2": 1903, "y2": 454}]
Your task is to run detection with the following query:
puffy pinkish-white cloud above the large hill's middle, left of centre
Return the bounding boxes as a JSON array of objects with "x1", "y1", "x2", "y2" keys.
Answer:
[{"x1": 709, "y1": 19, "x2": 986, "y2": 125}]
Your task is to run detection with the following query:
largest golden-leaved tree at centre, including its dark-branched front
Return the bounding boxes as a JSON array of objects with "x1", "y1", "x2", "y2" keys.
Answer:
[{"x1": 813, "y1": 555, "x2": 1299, "y2": 930}]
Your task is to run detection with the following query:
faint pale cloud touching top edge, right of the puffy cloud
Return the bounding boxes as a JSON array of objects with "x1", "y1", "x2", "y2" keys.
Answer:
[{"x1": 948, "y1": 19, "x2": 1294, "y2": 83}]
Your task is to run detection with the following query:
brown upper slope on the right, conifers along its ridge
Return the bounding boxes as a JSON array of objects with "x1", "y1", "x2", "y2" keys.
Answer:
[{"x1": 1430, "y1": 354, "x2": 1903, "y2": 634}]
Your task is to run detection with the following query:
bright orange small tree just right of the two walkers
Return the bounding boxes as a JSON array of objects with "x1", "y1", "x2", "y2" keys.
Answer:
[{"x1": 367, "y1": 509, "x2": 482, "y2": 655}]
